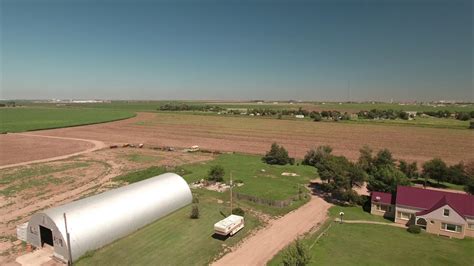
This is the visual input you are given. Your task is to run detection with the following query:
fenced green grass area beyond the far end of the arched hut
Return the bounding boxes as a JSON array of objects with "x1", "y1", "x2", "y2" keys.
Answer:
[{"x1": 114, "y1": 154, "x2": 318, "y2": 216}]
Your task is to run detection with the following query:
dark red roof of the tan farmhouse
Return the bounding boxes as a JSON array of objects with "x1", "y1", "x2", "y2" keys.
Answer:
[{"x1": 396, "y1": 186, "x2": 474, "y2": 217}]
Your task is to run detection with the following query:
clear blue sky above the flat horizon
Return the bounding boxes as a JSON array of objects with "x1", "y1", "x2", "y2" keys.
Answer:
[{"x1": 0, "y1": 0, "x2": 474, "y2": 101}]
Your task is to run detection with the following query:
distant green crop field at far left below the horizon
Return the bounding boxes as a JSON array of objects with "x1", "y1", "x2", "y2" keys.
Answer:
[{"x1": 0, "y1": 107, "x2": 135, "y2": 132}]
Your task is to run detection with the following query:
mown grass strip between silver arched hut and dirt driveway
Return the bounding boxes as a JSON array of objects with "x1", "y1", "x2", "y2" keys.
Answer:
[{"x1": 75, "y1": 195, "x2": 259, "y2": 265}]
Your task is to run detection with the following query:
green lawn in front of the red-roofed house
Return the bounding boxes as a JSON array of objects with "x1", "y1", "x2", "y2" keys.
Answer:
[{"x1": 268, "y1": 222, "x2": 474, "y2": 265}]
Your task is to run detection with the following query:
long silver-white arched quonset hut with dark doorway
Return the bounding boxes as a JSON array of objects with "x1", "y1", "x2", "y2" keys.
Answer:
[{"x1": 27, "y1": 173, "x2": 192, "y2": 262}]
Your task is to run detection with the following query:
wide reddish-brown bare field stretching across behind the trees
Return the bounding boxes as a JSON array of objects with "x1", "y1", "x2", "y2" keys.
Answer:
[{"x1": 0, "y1": 113, "x2": 474, "y2": 165}]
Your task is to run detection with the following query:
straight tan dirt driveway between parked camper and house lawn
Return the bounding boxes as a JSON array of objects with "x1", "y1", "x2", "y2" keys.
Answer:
[{"x1": 212, "y1": 196, "x2": 331, "y2": 266}]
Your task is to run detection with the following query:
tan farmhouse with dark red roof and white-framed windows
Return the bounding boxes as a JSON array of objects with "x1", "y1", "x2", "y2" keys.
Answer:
[{"x1": 371, "y1": 186, "x2": 474, "y2": 238}]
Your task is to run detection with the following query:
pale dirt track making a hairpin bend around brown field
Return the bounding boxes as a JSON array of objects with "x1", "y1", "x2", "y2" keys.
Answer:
[{"x1": 0, "y1": 133, "x2": 106, "y2": 169}]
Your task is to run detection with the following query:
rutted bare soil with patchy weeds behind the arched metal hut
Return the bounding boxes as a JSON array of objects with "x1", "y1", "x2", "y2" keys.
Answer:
[{"x1": 0, "y1": 148, "x2": 213, "y2": 265}]
